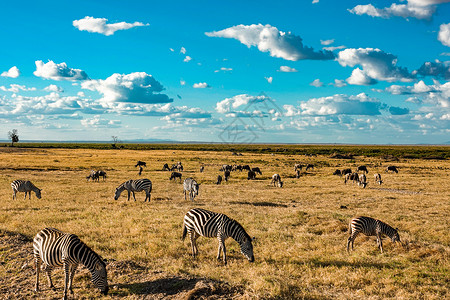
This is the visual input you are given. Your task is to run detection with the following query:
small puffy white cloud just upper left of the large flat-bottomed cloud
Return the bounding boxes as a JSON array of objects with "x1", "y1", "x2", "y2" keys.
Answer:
[{"x1": 33, "y1": 60, "x2": 89, "y2": 80}]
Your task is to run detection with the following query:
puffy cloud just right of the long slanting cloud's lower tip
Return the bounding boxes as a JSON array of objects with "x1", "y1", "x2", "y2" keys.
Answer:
[{"x1": 337, "y1": 48, "x2": 414, "y2": 85}]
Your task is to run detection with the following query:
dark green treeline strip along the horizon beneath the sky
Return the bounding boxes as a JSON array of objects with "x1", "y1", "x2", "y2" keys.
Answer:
[{"x1": 0, "y1": 143, "x2": 450, "y2": 159}]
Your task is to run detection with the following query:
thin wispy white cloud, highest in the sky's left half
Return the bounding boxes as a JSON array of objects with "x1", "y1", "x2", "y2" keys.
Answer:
[{"x1": 72, "y1": 16, "x2": 149, "y2": 36}]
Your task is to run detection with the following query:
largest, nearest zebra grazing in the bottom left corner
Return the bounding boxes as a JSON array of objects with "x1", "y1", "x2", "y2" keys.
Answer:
[{"x1": 33, "y1": 228, "x2": 108, "y2": 299}]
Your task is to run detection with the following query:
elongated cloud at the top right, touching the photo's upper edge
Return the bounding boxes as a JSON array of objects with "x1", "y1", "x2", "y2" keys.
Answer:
[{"x1": 349, "y1": 0, "x2": 440, "y2": 20}]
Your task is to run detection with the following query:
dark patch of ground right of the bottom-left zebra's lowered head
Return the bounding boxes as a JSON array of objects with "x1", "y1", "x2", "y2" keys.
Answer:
[{"x1": 117, "y1": 276, "x2": 240, "y2": 299}]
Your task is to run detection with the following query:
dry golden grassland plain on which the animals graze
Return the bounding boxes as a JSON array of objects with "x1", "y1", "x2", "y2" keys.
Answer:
[{"x1": 0, "y1": 145, "x2": 450, "y2": 299}]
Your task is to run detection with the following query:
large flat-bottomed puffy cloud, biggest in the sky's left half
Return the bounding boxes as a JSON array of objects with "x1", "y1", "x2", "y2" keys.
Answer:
[{"x1": 81, "y1": 72, "x2": 173, "y2": 103}]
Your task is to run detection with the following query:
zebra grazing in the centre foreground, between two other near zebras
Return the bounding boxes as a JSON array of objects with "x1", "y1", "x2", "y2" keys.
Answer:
[{"x1": 182, "y1": 208, "x2": 255, "y2": 264}]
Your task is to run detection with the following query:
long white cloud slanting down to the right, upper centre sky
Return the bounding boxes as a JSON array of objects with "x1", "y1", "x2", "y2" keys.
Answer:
[{"x1": 205, "y1": 24, "x2": 335, "y2": 61}]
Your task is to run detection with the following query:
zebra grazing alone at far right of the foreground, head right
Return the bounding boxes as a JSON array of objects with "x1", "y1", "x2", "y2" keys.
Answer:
[{"x1": 347, "y1": 217, "x2": 400, "y2": 253}]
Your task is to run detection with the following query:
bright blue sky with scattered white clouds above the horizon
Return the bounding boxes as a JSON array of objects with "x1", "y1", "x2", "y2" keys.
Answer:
[{"x1": 0, "y1": 0, "x2": 450, "y2": 144}]
